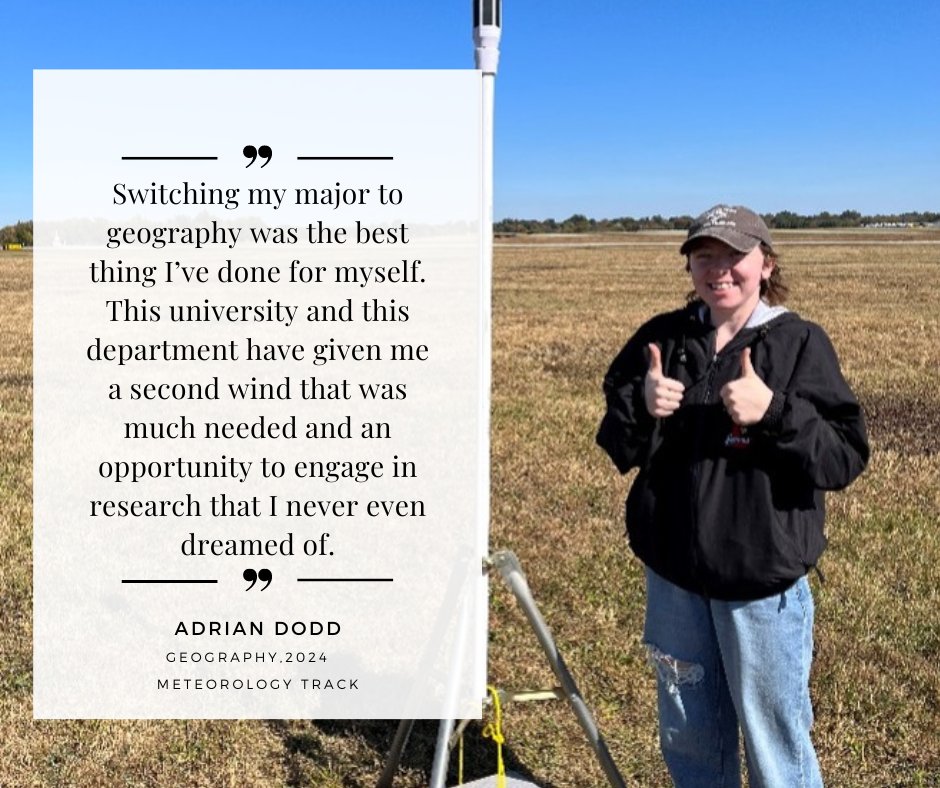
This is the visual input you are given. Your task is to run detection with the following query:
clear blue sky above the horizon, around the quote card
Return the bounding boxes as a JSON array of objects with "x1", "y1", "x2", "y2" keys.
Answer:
[{"x1": 0, "y1": 0, "x2": 940, "y2": 225}]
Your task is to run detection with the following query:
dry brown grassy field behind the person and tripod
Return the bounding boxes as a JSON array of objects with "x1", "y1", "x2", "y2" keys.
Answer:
[{"x1": 0, "y1": 231, "x2": 940, "y2": 788}]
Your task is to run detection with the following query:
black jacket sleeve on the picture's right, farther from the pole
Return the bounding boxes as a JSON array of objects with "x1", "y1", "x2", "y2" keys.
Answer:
[{"x1": 760, "y1": 324, "x2": 869, "y2": 490}]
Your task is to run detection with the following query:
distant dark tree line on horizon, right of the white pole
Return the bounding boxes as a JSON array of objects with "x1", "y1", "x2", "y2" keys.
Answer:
[{"x1": 493, "y1": 211, "x2": 940, "y2": 233}]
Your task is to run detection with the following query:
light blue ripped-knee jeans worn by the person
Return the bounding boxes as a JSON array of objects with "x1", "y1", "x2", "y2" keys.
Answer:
[{"x1": 643, "y1": 569, "x2": 822, "y2": 788}]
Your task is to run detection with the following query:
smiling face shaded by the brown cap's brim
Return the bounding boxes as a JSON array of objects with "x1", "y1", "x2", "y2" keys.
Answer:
[{"x1": 689, "y1": 238, "x2": 774, "y2": 320}]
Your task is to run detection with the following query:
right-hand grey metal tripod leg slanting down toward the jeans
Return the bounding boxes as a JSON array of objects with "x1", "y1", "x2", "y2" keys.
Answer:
[{"x1": 490, "y1": 550, "x2": 626, "y2": 788}]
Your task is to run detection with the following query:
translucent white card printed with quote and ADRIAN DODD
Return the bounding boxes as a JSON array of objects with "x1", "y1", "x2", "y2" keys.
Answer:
[{"x1": 34, "y1": 71, "x2": 489, "y2": 719}]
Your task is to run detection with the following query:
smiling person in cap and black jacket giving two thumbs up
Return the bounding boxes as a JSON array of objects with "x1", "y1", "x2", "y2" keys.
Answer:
[{"x1": 597, "y1": 205, "x2": 868, "y2": 788}]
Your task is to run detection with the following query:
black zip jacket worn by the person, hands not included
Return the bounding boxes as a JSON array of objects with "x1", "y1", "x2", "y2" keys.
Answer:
[{"x1": 597, "y1": 305, "x2": 868, "y2": 600}]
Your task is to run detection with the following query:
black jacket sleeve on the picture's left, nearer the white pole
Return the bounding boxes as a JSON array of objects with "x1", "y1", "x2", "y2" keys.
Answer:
[{"x1": 597, "y1": 330, "x2": 656, "y2": 473}]
